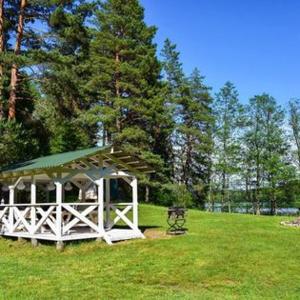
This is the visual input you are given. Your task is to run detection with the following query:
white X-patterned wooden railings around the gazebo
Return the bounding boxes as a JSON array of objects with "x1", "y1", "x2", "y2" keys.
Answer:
[{"x1": 0, "y1": 203, "x2": 137, "y2": 237}]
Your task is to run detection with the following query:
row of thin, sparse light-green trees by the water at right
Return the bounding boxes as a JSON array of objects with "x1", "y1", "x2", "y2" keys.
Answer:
[{"x1": 209, "y1": 91, "x2": 300, "y2": 214}]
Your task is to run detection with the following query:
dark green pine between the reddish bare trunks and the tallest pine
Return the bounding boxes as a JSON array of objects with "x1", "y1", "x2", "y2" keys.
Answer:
[{"x1": 34, "y1": 1, "x2": 97, "y2": 153}]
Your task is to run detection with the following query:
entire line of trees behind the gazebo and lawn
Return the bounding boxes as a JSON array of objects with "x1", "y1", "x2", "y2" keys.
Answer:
[{"x1": 0, "y1": 0, "x2": 300, "y2": 212}]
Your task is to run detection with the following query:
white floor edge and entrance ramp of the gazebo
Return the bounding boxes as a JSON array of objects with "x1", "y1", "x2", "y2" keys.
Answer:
[{"x1": 2, "y1": 227, "x2": 144, "y2": 242}]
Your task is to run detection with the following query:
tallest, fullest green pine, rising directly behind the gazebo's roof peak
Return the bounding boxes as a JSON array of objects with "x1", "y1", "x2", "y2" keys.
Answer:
[{"x1": 85, "y1": 0, "x2": 172, "y2": 202}]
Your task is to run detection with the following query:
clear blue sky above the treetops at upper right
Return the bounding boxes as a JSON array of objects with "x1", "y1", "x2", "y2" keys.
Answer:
[{"x1": 141, "y1": 0, "x2": 300, "y2": 106}]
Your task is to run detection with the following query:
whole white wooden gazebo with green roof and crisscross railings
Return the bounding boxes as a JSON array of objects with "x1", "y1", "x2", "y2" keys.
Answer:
[{"x1": 0, "y1": 146, "x2": 153, "y2": 248}]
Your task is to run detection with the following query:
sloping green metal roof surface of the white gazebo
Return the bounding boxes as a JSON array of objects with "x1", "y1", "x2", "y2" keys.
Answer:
[{"x1": 0, "y1": 145, "x2": 111, "y2": 177}]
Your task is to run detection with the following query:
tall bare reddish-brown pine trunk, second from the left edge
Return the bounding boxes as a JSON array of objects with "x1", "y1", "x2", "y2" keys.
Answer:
[{"x1": 8, "y1": 0, "x2": 27, "y2": 120}]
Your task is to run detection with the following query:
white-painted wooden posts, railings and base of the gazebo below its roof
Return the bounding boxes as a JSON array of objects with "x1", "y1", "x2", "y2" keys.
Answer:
[{"x1": 0, "y1": 157, "x2": 143, "y2": 244}]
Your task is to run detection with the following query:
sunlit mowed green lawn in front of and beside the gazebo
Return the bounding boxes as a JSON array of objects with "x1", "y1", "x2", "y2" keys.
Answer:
[{"x1": 0, "y1": 205, "x2": 300, "y2": 299}]
